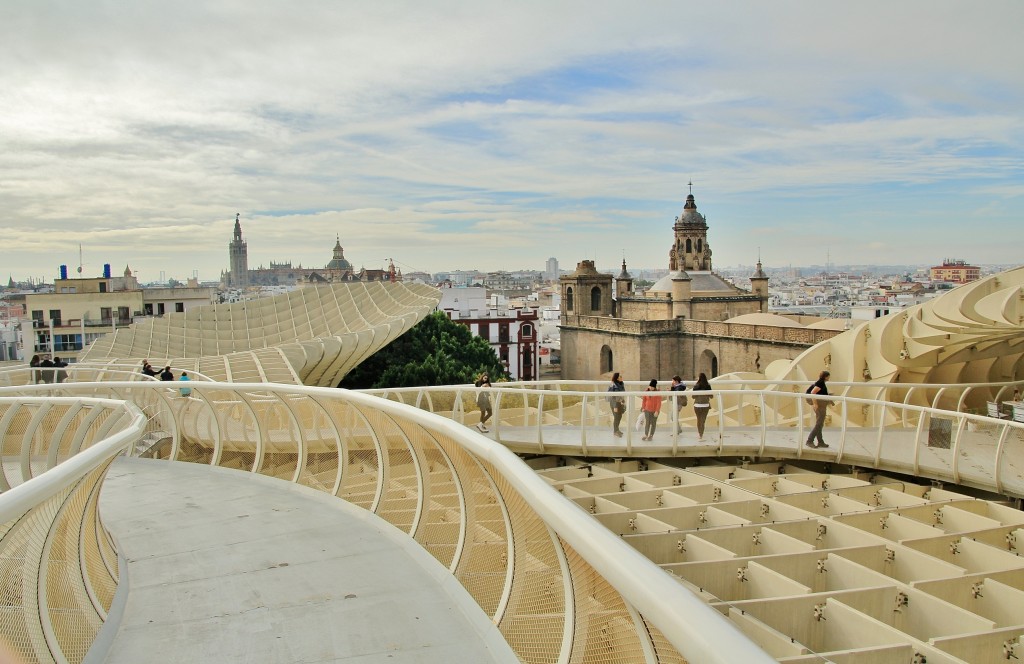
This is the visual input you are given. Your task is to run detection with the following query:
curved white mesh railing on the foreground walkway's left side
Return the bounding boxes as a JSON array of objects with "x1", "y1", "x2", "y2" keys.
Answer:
[{"x1": 0, "y1": 397, "x2": 145, "y2": 662}]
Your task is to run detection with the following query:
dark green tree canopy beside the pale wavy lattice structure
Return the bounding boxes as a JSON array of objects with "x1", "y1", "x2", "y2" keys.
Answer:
[{"x1": 338, "y1": 312, "x2": 505, "y2": 389}]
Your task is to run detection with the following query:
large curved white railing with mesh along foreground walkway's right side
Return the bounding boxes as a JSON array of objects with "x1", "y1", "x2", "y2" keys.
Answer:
[{"x1": 0, "y1": 382, "x2": 772, "y2": 664}]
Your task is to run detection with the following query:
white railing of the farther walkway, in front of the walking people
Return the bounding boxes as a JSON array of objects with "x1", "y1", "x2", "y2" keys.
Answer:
[{"x1": 368, "y1": 382, "x2": 1024, "y2": 497}]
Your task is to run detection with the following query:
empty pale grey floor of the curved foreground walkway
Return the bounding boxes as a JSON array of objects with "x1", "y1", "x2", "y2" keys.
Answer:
[{"x1": 93, "y1": 458, "x2": 518, "y2": 664}]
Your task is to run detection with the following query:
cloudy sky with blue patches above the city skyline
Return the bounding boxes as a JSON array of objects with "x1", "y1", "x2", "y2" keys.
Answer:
[{"x1": 0, "y1": 0, "x2": 1024, "y2": 281}]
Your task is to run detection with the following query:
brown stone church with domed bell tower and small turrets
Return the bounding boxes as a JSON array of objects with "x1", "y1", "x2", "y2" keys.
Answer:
[{"x1": 559, "y1": 194, "x2": 835, "y2": 381}]
